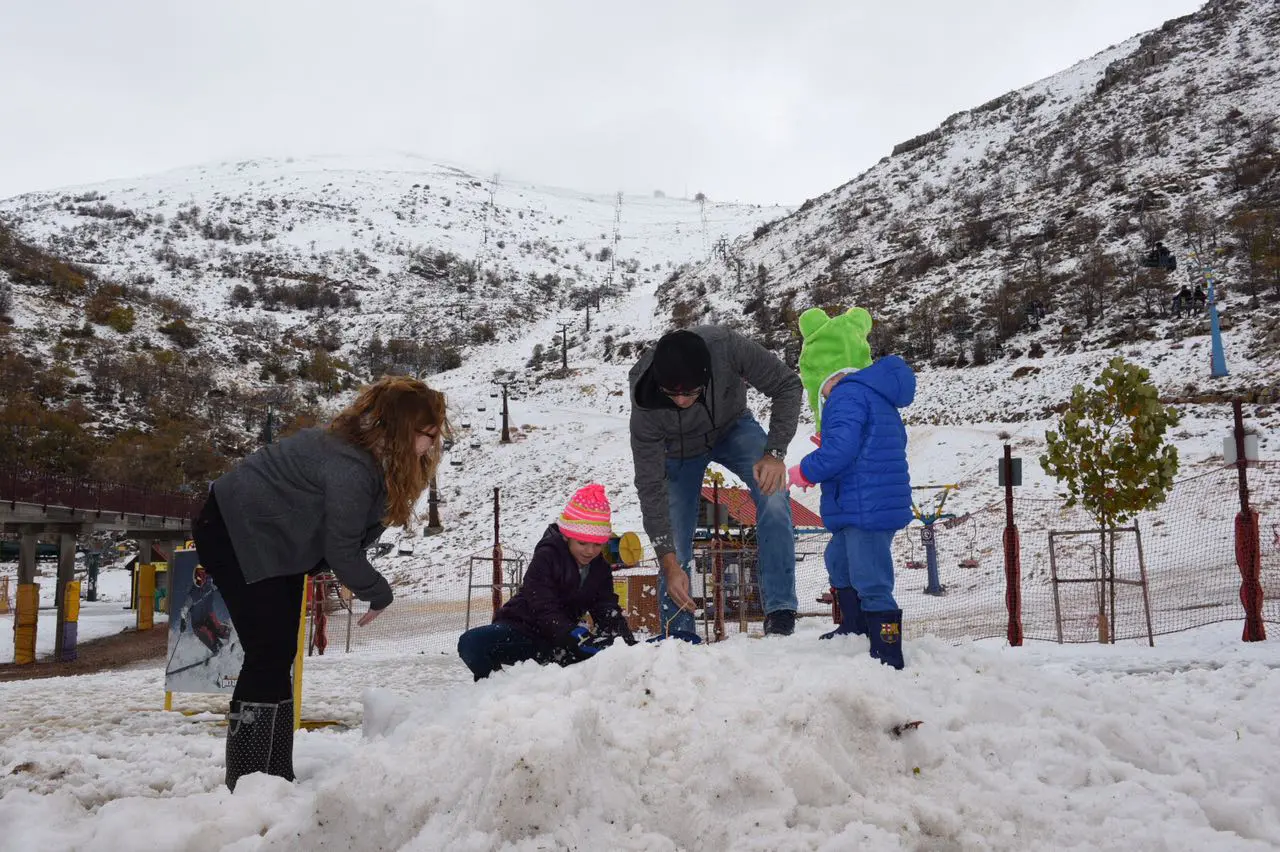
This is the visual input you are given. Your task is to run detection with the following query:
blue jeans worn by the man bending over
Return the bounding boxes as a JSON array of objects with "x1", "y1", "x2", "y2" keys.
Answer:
[{"x1": 658, "y1": 414, "x2": 796, "y2": 632}]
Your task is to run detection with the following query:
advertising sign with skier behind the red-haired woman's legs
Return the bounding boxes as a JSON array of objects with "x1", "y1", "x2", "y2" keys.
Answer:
[{"x1": 164, "y1": 549, "x2": 244, "y2": 692}]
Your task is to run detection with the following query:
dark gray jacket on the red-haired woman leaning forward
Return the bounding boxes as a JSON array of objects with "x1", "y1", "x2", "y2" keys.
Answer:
[{"x1": 214, "y1": 429, "x2": 392, "y2": 609}]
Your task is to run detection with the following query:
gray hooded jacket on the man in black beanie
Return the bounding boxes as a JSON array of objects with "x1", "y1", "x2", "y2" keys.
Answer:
[{"x1": 630, "y1": 325, "x2": 804, "y2": 558}]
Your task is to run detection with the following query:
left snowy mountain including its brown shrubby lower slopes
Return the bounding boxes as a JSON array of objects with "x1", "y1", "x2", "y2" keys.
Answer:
[{"x1": 0, "y1": 149, "x2": 788, "y2": 473}]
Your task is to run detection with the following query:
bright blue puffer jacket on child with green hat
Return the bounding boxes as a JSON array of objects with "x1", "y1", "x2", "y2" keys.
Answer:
[{"x1": 800, "y1": 356, "x2": 915, "y2": 530}]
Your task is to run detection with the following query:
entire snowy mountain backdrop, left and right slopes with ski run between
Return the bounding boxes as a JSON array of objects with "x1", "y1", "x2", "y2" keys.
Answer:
[{"x1": 0, "y1": 0, "x2": 1280, "y2": 562}]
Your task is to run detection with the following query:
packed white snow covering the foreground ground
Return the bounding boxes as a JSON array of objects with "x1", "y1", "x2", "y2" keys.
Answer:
[{"x1": 0, "y1": 623, "x2": 1280, "y2": 852}]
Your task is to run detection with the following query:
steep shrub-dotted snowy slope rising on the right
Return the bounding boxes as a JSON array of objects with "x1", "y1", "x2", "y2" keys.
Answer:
[{"x1": 659, "y1": 0, "x2": 1280, "y2": 422}]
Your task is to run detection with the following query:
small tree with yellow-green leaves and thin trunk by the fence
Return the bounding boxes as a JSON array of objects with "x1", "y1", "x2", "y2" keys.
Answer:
[{"x1": 1041, "y1": 357, "x2": 1179, "y2": 641}]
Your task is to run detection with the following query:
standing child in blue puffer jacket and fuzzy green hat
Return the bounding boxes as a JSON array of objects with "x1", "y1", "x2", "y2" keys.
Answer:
[{"x1": 788, "y1": 308, "x2": 915, "y2": 669}]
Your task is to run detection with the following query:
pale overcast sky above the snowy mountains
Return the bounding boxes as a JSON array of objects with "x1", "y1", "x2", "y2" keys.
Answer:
[{"x1": 0, "y1": 0, "x2": 1201, "y2": 202}]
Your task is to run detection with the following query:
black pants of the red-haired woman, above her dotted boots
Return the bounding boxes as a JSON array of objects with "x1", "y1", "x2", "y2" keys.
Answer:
[{"x1": 192, "y1": 491, "x2": 302, "y2": 702}]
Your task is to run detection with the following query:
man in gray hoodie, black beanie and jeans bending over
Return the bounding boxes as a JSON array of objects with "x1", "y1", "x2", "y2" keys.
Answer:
[{"x1": 630, "y1": 326, "x2": 803, "y2": 636}]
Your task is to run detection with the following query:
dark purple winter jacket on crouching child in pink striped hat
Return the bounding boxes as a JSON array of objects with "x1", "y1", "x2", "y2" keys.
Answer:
[{"x1": 493, "y1": 523, "x2": 635, "y2": 645}]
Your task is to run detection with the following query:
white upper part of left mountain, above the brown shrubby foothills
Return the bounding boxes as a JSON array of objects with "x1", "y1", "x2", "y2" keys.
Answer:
[{"x1": 0, "y1": 155, "x2": 788, "y2": 414}]
